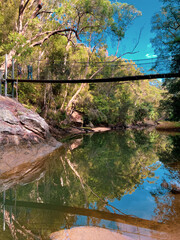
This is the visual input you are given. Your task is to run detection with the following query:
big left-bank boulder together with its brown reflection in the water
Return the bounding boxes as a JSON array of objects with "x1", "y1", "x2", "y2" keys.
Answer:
[{"x1": 0, "y1": 96, "x2": 62, "y2": 191}]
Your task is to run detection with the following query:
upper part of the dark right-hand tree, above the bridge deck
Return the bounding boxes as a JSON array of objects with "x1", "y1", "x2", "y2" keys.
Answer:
[{"x1": 151, "y1": 0, "x2": 180, "y2": 71}]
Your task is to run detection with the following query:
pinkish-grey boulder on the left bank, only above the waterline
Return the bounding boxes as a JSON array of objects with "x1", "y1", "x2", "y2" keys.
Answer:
[{"x1": 0, "y1": 96, "x2": 50, "y2": 145}]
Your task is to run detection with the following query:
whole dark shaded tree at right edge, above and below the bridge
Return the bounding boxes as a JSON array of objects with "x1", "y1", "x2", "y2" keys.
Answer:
[{"x1": 151, "y1": 0, "x2": 180, "y2": 121}]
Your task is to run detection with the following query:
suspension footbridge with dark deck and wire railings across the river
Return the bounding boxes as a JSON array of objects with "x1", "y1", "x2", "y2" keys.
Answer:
[{"x1": 0, "y1": 55, "x2": 180, "y2": 97}]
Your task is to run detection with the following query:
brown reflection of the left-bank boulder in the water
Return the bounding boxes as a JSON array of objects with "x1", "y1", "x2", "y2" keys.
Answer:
[{"x1": 0, "y1": 138, "x2": 63, "y2": 192}]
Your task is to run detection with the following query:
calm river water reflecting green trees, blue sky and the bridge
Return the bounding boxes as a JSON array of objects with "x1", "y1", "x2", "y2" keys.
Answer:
[{"x1": 0, "y1": 131, "x2": 180, "y2": 240}]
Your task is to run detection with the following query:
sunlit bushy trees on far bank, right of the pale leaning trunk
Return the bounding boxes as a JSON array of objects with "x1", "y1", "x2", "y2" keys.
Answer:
[{"x1": 76, "y1": 60, "x2": 161, "y2": 125}]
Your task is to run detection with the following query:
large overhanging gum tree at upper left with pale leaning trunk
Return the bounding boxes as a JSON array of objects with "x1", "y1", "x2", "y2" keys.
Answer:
[{"x1": 1, "y1": 0, "x2": 141, "y2": 120}]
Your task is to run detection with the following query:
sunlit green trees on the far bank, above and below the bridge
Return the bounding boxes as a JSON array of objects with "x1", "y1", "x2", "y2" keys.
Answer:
[{"x1": 0, "y1": 0, "x2": 161, "y2": 125}]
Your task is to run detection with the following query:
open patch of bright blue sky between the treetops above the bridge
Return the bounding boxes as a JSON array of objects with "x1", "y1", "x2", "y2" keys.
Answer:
[{"x1": 108, "y1": 0, "x2": 162, "y2": 60}]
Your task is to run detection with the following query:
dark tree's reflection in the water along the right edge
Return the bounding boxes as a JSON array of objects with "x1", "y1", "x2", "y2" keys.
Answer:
[{"x1": 152, "y1": 135, "x2": 180, "y2": 239}]
